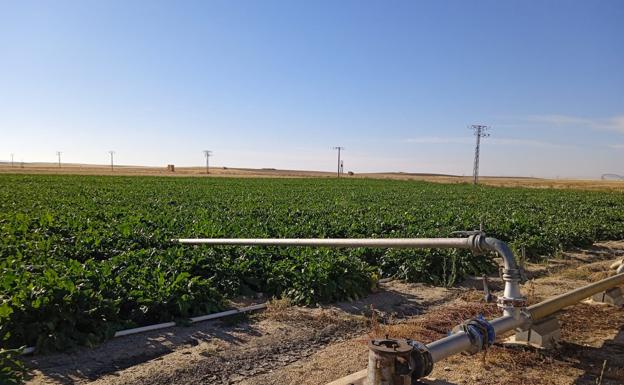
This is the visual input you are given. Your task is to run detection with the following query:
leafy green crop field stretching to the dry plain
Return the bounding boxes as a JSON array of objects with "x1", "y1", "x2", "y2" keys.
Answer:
[{"x1": 0, "y1": 175, "x2": 624, "y2": 360}]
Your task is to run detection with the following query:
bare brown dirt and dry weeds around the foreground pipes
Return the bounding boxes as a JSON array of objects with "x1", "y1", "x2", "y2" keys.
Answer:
[{"x1": 22, "y1": 241, "x2": 624, "y2": 385}]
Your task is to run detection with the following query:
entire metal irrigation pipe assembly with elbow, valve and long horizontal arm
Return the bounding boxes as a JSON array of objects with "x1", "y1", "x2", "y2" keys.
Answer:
[{"x1": 173, "y1": 232, "x2": 624, "y2": 384}]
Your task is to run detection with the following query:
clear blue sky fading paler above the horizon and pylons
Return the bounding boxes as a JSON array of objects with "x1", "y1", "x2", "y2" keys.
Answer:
[{"x1": 0, "y1": 0, "x2": 624, "y2": 178}]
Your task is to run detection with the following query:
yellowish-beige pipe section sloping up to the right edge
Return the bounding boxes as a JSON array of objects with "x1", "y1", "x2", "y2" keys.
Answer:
[{"x1": 527, "y1": 273, "x2": 624, "y2": 321}]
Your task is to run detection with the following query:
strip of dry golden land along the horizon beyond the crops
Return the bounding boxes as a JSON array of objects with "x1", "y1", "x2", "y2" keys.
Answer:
[{"x1": 0, "y1": 163, "x2": 624, "y2": 191}]
